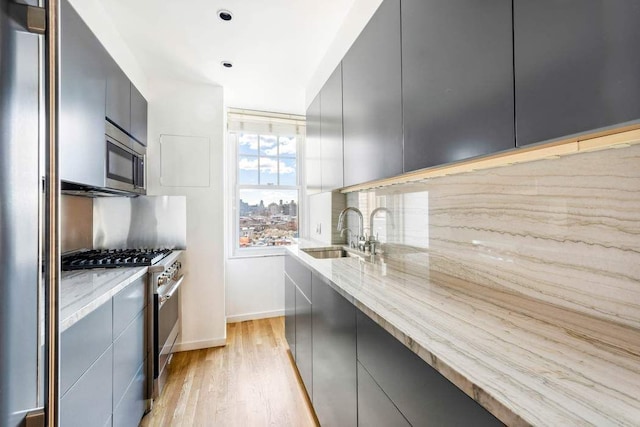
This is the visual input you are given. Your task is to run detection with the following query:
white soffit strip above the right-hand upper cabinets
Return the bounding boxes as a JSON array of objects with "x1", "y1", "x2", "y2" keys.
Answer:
[{"x1": 305, "y1": 0, "x2": 382, "y2": 110}]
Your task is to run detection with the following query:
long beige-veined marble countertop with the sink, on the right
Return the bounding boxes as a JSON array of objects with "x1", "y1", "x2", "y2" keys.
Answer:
[{"x1": 288, "y1": 244, "x2": 640, "y2": 426}]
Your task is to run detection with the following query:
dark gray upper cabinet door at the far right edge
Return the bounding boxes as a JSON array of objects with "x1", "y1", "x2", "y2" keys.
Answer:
[{"x1": 513, "y1": 0, "x2": 640, "y2": 146}]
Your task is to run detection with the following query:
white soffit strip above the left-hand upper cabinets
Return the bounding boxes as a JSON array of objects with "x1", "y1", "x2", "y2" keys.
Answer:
[{"x1": 69, "y1": 0, "x2": 149, "y2": 98}]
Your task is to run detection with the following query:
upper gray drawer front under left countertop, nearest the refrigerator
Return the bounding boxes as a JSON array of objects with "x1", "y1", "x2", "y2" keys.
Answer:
[{"x1": 60, "y1": 300, "x2": 112, "y2": 396}]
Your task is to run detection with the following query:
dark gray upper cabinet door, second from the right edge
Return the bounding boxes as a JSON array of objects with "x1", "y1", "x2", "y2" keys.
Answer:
[{"x1": 402, "y1": 0, "x2": 515, "y2": 172}]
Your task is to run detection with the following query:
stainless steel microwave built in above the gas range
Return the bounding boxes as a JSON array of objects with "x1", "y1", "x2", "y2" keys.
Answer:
[{"x1": 105, "y1": 121, "x2": 147, "y2": 194}]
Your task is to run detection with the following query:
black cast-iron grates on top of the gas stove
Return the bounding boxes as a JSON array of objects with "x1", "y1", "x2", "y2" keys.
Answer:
[{"x1": 61, "y1": 249, "x2": 171, "y2": 271}]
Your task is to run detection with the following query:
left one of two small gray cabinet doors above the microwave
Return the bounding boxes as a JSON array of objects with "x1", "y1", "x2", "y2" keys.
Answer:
[{"x1": 106, "y1": 57, "x2": 131, "y2": 133}]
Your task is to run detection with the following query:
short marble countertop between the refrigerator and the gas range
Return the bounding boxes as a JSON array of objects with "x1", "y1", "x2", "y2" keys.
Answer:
[{"x1": 60, "y1": 267, "x2": 148, "y2": 332}]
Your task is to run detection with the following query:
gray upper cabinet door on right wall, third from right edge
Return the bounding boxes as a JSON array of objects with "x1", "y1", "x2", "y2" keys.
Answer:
[{"x1": 342, "y1": 0, "x2": 402, "y2": 186}]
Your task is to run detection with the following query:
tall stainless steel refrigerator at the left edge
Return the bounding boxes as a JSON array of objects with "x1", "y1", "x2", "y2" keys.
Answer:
[{"x1": 0, "y1": 0, "x2": 46, "y2": 427}]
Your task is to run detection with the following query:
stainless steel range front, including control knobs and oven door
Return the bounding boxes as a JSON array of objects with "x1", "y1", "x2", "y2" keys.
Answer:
[{"x1": 149, "y1": 251, "x2": 185, "y2": 397}]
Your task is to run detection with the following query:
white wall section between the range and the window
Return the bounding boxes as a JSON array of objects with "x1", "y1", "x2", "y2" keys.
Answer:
[{"x1": 147, "y1": 79, "x2": 226, "y2": 351}]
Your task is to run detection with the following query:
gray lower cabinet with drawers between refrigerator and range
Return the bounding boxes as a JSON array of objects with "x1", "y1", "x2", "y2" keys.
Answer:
[{"x1": 60, "y1": 276, "x2": 148, "y2": 427}]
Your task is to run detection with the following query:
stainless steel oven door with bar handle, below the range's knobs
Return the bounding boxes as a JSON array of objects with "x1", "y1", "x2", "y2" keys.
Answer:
[{"x1": 153, "y1": 276, "x2": 184, "y2": 397}]
